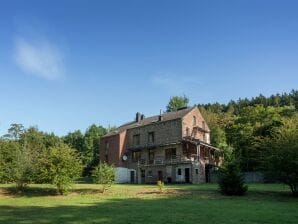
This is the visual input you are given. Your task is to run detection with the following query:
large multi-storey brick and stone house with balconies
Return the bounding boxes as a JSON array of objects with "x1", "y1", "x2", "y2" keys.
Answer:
[{"x1": 100, "y1": 107, "x2": 221, "y2": 183}]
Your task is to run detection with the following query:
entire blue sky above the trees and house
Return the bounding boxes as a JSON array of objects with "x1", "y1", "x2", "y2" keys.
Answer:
[{"x1": 0, "y1": 0, "x2": 298, "y2": 135}]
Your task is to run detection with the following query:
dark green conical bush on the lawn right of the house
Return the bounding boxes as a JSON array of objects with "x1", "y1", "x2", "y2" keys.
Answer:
[{"x1": 219, "y1": 161, "x2": 247, "y2": 196}]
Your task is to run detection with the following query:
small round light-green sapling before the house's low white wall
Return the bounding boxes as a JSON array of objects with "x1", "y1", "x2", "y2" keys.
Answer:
[{"x1": 92, "y1": 163, "x2": 115, "y2": 193}]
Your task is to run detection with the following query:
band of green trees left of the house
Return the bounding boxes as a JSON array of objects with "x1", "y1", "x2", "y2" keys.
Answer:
[{"x1": 0, "y1": 124, "x2": 107, "y2": 194}]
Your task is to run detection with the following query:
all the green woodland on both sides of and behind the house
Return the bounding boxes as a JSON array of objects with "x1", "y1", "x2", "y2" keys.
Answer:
[{"x1": 0, "y1": 90, "x2": 298, "y2": 194}]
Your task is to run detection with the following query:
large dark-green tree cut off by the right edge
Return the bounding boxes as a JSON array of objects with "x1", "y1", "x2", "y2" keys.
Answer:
[{"x1": 264, "y1": 114, "x2": 298, "y2": 196}]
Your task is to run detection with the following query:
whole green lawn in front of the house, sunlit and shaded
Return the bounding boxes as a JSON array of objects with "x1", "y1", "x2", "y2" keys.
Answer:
[{"x1": 0, "y1": 184, "x2": 298, "y2": 224}]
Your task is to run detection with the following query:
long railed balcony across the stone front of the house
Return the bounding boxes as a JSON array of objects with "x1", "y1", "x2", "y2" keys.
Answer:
[{"x1": 138, "y1": 155, "x2": 197, "y2": 166}]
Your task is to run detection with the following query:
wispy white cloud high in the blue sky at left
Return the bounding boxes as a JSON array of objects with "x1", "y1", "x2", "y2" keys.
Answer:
[{"x1": 14, "y1": 38, "x2": 64, "y2": 80}]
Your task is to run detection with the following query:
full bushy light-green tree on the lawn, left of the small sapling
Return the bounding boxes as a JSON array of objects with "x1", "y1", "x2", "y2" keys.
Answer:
[{"x1": 40, "y1": 143, "x2": 82, "y2": 195}]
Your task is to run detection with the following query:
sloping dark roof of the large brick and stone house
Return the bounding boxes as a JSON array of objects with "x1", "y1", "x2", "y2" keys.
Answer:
[{"x1": 103, "y1": 106, "x2": 196, "y2": 137}]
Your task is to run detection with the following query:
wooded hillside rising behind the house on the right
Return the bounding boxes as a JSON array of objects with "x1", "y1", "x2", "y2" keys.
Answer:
[{"x1": 199, "y1": 90, "x2": 298, "y2": 171}]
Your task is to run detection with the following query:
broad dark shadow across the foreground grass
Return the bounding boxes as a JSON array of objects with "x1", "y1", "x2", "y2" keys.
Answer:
[{"x1": 0, "y1": 197, "x2": 298, "y2": 224}]
